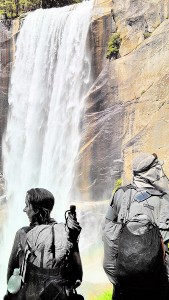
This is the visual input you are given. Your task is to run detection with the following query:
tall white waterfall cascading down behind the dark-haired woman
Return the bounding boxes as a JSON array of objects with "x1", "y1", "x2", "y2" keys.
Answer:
[{"x1": 0, "y1": 2, "x2": 92, "y2": 296}]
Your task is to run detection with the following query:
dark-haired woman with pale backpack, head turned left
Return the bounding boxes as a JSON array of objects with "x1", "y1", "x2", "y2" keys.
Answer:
[{"x1": 4, "y1": 188, "x2": 83, "y2": 300}]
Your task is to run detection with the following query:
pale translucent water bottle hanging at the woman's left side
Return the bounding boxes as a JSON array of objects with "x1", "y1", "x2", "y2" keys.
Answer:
[{"x1": 7, "y1": 269, "x2": 21, "y2": 294}]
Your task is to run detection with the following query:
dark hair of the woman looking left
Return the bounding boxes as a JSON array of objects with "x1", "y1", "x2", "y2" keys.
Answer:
[{"x1": 27, "y1": 188, "x2": 55, "y2": 225}]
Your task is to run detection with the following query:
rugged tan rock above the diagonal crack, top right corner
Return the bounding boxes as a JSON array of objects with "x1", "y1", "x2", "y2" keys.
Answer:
[{"x1": 113, "y1": 0, "x2": 169, "y2": 56}]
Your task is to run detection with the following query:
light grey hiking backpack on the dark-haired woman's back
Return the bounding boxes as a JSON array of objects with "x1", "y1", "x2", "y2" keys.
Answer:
[{"x1": 21, "y1": 223, "x2": 73, "y2": 281}]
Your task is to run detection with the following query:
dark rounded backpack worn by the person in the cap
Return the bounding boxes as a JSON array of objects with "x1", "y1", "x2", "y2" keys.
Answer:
[{"x1": 116, "y1": 187, "x2": 164, "y2": 287}]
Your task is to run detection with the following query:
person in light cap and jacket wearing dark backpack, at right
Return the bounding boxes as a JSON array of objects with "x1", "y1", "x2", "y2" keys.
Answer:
[{"x1": 103, "y1": 153, "x2": 169, "y2": 300}]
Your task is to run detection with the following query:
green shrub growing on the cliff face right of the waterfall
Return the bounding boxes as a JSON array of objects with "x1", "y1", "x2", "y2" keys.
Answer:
[{"x1": 106, "y1": 33, "x2": 121, "y2": 59}]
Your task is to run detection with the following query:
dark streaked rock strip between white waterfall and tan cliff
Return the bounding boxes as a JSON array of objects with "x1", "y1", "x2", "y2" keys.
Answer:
[{"x1": 77, "y1": 10, "x2": 124, "y2": 200}]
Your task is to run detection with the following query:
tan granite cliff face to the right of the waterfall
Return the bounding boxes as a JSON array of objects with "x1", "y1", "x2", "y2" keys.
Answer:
[{"x1": 79, "y1": 0, "x2": 169, "y2": 200}]
